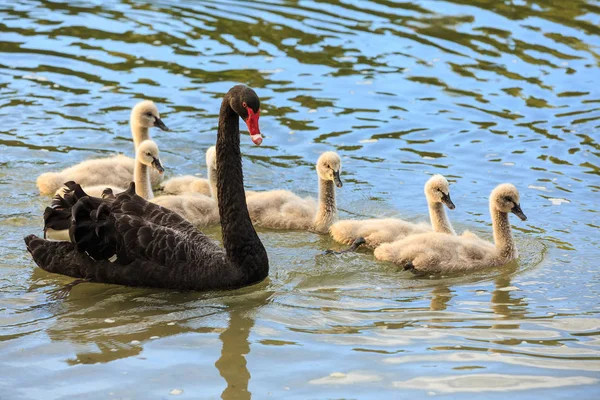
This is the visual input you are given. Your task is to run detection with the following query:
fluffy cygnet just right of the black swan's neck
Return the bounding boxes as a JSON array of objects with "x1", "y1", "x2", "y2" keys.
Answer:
[{"x1": 246, "y1": 151, "x2": 342, "y2": 233}]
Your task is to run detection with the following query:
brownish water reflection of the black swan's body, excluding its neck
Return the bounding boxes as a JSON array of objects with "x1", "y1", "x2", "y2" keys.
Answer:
[{"x1": 32, "y1": 280, "x2": 223, "y2": 364}]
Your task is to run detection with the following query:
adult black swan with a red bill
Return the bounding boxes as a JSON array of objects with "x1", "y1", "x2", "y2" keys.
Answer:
[{"x1": 25, "y1": 85, "x2": 269, "y2": 290}]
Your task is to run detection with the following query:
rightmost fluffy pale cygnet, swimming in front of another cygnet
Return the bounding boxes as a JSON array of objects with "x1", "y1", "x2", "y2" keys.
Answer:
[{"x1": 374, "y1": 184, "x2": 527, "y2": 273}]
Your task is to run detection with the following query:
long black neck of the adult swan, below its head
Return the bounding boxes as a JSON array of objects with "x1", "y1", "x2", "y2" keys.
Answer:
[{"x1": 217, "y1": 92, "x2": 269, "y2": 283}]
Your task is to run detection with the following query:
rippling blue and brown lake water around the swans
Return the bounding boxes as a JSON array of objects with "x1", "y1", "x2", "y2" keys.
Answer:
[{"x1": 0, "y1": 0, "x2": 600, "y2": 400}]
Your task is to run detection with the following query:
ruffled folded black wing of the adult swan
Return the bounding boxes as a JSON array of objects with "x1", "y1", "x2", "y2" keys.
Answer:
[{"x1": 70, "y1": 184, "x2": 223, "y2": 266}]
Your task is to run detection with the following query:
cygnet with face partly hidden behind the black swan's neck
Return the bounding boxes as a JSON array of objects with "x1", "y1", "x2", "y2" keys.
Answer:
[{"x1": 161, "y1": 146, "x2": 217, "y2": 198}]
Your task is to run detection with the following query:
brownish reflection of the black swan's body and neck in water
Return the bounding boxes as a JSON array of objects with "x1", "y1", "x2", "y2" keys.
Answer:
[{"x1": 29, "y1": 262, "x2": 273, "y2": 400}]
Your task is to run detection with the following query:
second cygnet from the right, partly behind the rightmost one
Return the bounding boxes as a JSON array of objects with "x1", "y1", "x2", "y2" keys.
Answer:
[{"x1": 329, "y1": 175, "x2": 454, "y2": 249}]
